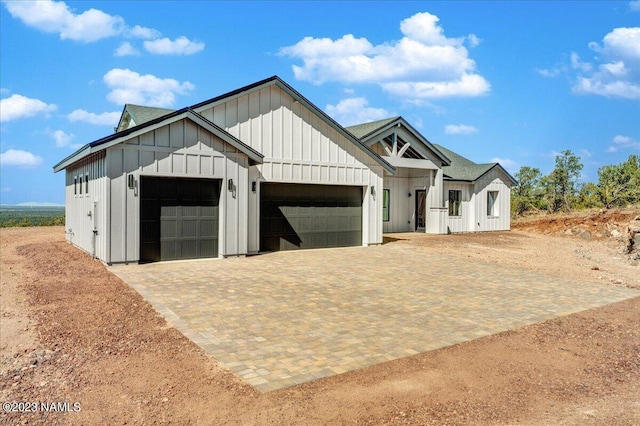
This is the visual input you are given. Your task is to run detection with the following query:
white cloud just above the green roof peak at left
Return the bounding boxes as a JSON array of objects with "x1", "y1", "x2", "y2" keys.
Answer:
[{"x1": 103, "y1": 68, "x2": 195, "y2": 107}]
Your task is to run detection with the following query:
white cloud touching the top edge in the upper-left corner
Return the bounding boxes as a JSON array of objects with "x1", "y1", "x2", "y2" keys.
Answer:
[{"x1": 4, "y1": 0, "x2": 124, "y2": 43}]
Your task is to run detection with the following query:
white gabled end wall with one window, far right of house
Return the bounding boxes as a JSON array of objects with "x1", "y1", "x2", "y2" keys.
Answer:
[{"x1": 472, "y1": 169, "x2": 511, "y2": 231}]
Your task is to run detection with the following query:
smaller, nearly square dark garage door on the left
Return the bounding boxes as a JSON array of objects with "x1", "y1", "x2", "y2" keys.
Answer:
[{"x1": 140, "y1": 176, "x2": 221, "y2": 262}]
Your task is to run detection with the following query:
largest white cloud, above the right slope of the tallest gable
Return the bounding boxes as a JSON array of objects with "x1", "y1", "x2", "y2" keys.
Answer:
[{"x1": 279, "y1": 12, "x2": 490, "y2": 99}]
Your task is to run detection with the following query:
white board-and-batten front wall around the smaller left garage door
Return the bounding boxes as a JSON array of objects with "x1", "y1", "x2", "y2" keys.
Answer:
[{"x1": 106, "y1": 119, "x2": 248, "y2": 263}]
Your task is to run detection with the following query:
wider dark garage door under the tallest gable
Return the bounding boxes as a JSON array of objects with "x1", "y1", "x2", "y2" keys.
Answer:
[{"x1": 260, "y1": 183, "x2": 362, "y2": 251}]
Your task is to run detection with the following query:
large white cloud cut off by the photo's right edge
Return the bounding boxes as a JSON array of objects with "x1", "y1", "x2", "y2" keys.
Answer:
[{"x1": 571, "y1": 27, "x2": 640, "y2": 99}]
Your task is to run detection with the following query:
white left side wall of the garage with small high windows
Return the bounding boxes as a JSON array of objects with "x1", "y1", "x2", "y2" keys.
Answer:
[{"x1": 65, "y1": 153, "x2": 108, "y2": 259}]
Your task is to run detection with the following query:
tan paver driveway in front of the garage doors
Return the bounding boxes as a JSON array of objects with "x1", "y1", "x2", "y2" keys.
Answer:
[{"x1": 110, "y1": 240, "x2": 640, "y2": 391}]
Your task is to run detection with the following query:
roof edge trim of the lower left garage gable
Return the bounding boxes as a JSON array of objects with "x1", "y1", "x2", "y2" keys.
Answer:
[{"x1": 53, "y1": 107, "x2": 264, "y2": 173}]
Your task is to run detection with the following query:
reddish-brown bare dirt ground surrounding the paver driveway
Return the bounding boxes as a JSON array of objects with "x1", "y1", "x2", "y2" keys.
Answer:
[{"x1": 0, "y1": 212, "x2": 640, "y2": 425}]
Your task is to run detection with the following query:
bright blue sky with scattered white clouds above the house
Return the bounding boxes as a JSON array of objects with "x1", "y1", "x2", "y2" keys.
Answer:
[{"x1": 0, "y1": 1, "x2": 640, "y2": 204}]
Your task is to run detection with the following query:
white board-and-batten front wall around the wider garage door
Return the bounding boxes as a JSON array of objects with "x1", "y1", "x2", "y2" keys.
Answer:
[{"x1": 197, "y1": 85, "x2": 383, "y2": 252}]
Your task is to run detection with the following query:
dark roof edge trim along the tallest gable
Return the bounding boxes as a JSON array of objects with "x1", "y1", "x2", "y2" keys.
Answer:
[{"x1": 190, "y1": 75, "x2": 396, "y2": 174}]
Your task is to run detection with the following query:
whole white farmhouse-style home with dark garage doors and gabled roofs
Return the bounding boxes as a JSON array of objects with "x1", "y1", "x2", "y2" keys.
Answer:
[{"x1": 54, "y1": 76, "x2": 514, "y2": 263}]
